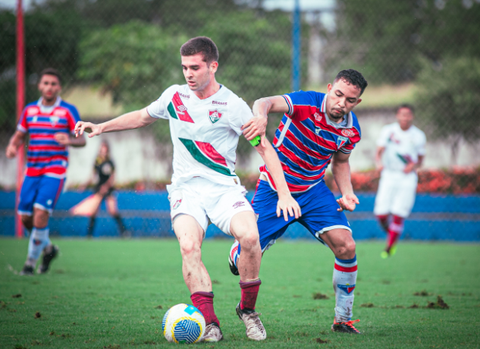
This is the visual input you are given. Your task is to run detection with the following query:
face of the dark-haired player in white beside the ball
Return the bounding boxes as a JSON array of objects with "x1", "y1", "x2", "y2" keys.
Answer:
[{"x1": 182, "y1": 53, "x2": 218, "y2": 92}]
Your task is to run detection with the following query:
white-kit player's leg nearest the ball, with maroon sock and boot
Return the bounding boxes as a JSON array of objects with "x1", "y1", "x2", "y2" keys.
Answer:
[{"x1": 173, "y1": 214, "x2": 223, "y2": 342}]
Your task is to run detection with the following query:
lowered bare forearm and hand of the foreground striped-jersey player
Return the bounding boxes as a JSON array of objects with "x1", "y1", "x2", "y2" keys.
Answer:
[{"x1": 332, "y1": 152, "x2": 360, "y2": 211}]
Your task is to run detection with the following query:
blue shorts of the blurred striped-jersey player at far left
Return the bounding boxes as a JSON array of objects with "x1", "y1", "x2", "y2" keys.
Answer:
[{"x1": 18, "y1": 176, "x2": 65, "y2": 215}]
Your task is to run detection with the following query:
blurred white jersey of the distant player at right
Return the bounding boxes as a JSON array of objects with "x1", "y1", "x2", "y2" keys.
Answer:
[{"x1": 377, "y1": 122, "x2": 427, "y2": 171}]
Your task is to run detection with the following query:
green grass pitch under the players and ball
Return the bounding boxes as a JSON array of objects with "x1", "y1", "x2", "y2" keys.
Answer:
[{"x1": 0, "y1": 238, "x2": 480, "y2": 349}]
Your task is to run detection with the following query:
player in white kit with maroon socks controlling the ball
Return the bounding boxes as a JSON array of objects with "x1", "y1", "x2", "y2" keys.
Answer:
[{"x1": 75, "y1": 37, "x2": 301, "y2": 342}]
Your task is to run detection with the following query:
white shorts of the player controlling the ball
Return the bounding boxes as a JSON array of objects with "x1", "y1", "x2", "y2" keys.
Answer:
[{"x1": 167, "y1": 177, "x2": 253, "y2": 235}]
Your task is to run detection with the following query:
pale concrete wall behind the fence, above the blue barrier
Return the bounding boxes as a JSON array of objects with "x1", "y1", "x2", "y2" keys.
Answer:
[{"x1": 0, "y1": 109, "x2": 480, "y2": 188}]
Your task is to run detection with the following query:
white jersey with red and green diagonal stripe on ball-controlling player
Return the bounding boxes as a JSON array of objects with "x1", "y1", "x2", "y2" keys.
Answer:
[{"x1": 147, "y1": 85, "x2": 253, "y2": 185}]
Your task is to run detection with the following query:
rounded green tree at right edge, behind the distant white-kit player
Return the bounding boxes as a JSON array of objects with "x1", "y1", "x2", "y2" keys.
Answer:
[{"x1": 417, "y1": 57, "x2": 480, "y2": 165}]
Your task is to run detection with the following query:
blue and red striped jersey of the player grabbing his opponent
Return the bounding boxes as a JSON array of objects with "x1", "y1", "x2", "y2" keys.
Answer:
[{"x1": 260, "y1": 91, "x2": 361, "y2": 193}]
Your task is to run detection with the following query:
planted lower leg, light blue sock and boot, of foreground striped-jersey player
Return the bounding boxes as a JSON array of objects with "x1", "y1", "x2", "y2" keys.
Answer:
[{"x1": 321, "y1": 229, "x2": 360, "y2": 334}]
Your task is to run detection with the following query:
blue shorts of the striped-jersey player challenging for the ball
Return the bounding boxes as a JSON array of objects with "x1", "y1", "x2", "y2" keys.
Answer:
[{"x1": 248, "y1": 180, "x2": 352, "y2": 252}]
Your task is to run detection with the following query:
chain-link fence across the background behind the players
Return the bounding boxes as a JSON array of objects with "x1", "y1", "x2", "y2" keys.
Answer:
[{"x1": 0, "y1": 0, "x2": 480, "y2": 239}]
